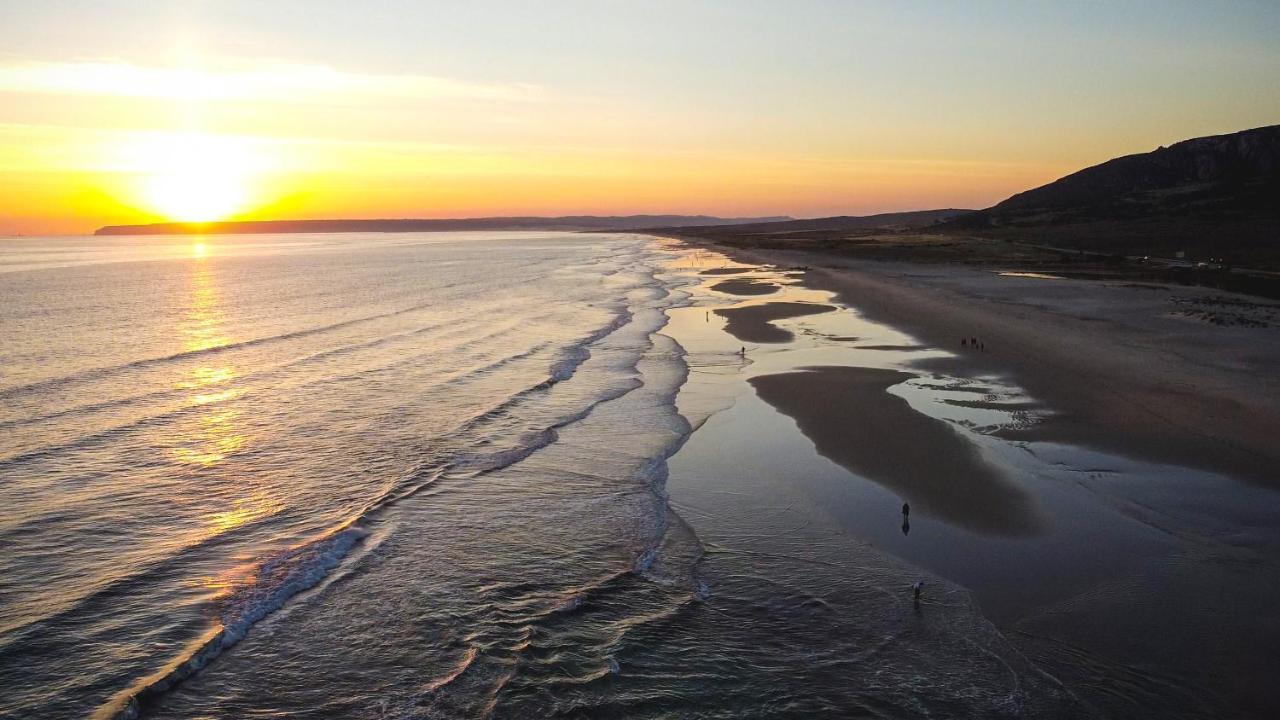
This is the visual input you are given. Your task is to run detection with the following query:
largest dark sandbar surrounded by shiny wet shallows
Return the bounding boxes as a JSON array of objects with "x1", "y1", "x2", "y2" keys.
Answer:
[{"x1": 750, "y1": 368, "x2": 1043, "y2": 536}]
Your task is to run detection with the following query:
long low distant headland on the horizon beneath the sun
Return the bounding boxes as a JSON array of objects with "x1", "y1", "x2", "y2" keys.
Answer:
[{"x1": 93, "y1": 215, "x2": 791, "y2": 234}]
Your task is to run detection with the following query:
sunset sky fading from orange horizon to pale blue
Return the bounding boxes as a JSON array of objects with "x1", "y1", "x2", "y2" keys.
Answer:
[{"x1": 0, "y1": 0, "x2": 1280, "y2": 234}]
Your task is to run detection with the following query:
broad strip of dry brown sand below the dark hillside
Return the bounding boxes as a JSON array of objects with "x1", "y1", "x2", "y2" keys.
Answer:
[{"x1": 677, "y1": 237, "x2": 1280, "y2": 488}]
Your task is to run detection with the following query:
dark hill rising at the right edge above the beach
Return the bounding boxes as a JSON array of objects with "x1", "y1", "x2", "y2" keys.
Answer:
[{"x1": 945, "y1": 126, "x2": 1280, "y2": 261}]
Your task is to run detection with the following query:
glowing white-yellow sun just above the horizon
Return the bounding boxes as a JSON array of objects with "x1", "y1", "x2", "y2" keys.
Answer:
[{"x1": 133, "y1": 133, "x2": 253, "y2": 223}]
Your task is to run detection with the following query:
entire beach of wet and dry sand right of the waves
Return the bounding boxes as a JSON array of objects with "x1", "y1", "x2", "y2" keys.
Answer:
[{"x1": 667, "y1": 237, "x2": 1280, "y2": 717}]
